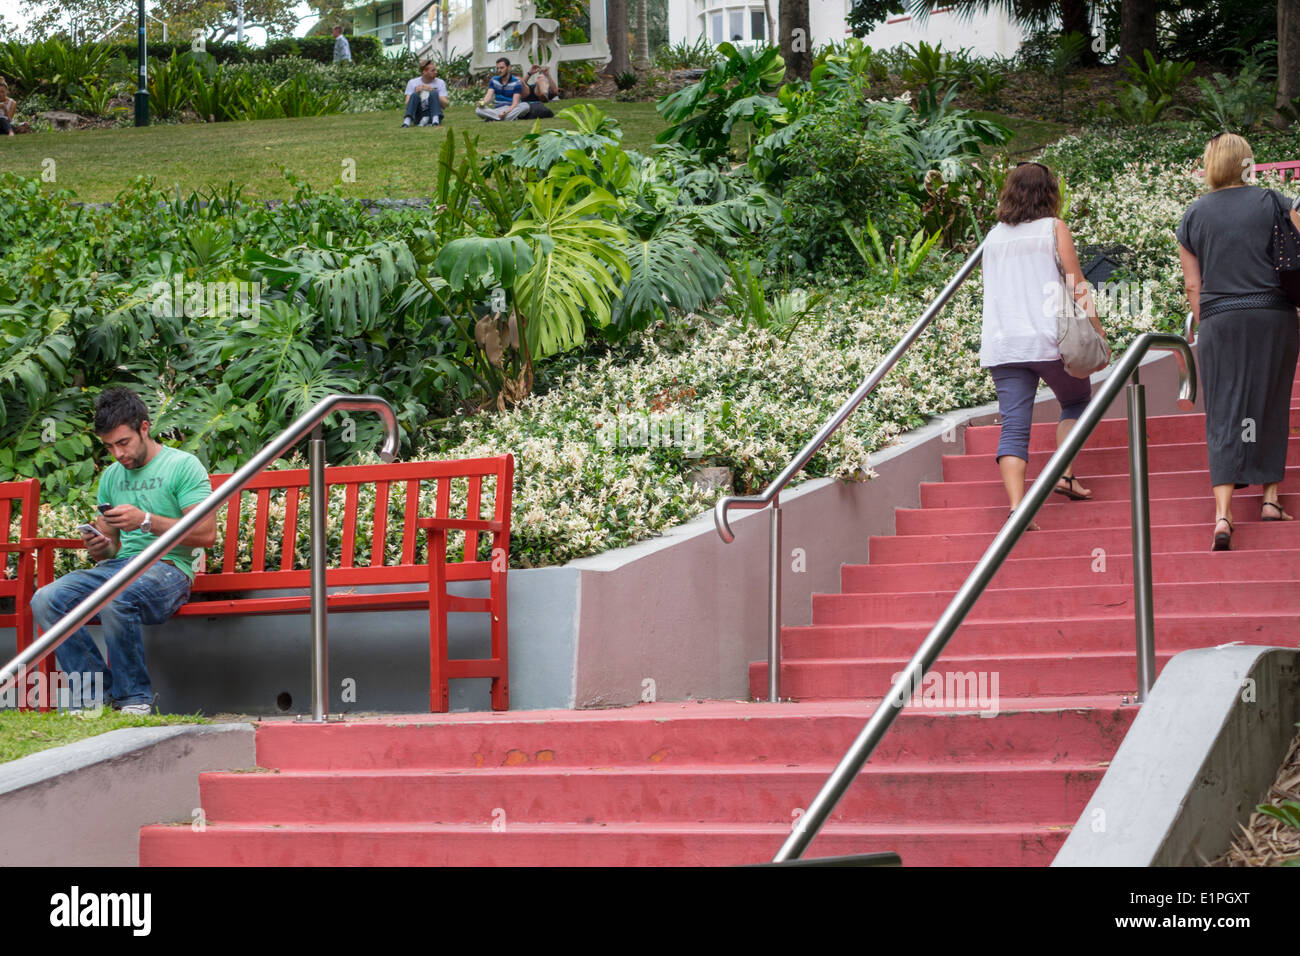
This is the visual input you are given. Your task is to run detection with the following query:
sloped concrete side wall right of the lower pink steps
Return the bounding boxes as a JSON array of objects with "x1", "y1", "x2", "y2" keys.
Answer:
[{"x1": 1052, "y1": 647, "x2": 1300, "y2": 866}]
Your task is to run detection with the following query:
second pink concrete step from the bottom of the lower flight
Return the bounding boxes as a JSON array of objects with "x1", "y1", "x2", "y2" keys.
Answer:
[{"x1": 199, "y1": 758, "x2": 1104, "y2": 826}]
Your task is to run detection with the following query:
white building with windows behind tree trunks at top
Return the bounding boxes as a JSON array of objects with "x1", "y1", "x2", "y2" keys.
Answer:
[{"x1": 668, "y1": 0, "x2": 1023, "y2": 56}]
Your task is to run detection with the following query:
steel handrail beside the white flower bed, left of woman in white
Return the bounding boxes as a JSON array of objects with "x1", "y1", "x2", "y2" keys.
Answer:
[{"x1": 714, "y1": 242, "x2": 984, "y2": 702}]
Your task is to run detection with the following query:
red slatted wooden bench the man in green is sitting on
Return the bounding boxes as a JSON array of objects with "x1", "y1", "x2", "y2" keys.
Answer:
[{"x1": 25, "y1": 455, "x2": 515, "y2": 713}]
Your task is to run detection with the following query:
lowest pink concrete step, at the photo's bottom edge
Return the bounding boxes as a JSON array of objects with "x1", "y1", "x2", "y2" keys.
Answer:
[{"x1": 140, "y1": 816, "x2": 1069, "y2": 866}]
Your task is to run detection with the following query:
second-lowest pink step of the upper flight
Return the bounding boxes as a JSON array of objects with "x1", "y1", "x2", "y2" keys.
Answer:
[{"x1": 780, "y1": 610, "x2": 1300, "y2": 658}]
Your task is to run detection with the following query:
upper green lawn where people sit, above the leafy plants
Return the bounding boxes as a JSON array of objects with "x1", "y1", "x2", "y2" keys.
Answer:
[{"x1": 0, "y1": 100, "x2": 664, "y2": 202}]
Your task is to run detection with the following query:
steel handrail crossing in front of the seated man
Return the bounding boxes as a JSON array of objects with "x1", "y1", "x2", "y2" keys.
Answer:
[{"x1": 0, "y1": 394, "x2": 398, "y2": 722}]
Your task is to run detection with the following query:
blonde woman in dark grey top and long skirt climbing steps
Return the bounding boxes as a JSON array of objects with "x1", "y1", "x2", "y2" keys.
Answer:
[{"x1": 1178, "y1": 133, "x2": 1300, "y2": 551}]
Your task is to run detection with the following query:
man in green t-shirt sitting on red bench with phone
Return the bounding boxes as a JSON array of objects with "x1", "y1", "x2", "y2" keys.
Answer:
[{"x1": 31, "y1": 389, "x2": 217, "y2": 714}]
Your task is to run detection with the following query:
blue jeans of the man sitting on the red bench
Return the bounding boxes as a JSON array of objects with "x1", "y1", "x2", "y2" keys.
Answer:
[{"x1": 31, "y1": 558, "x2": 190, "y2": 708}]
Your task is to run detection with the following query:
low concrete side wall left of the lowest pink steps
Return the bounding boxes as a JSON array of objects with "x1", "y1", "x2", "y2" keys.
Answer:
[{"x1": 0, "y1": 723, "x2": 257, "y2": 866}]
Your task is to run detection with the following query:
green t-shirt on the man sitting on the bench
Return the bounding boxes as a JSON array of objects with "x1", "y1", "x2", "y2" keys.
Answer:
[{"x1": 99, "y1": 445, "x2": 212, "y2": 581}]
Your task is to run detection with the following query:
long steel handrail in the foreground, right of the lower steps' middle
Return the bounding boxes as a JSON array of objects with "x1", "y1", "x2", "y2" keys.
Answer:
[{"x1": 774, "y1": 332, "x2": 1196, "y2": 862}]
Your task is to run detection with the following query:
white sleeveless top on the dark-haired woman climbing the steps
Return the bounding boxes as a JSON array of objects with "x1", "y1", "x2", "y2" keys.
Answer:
[{"x1": 979, "y1": 216, "x2": 1061, "y2": 368}]
